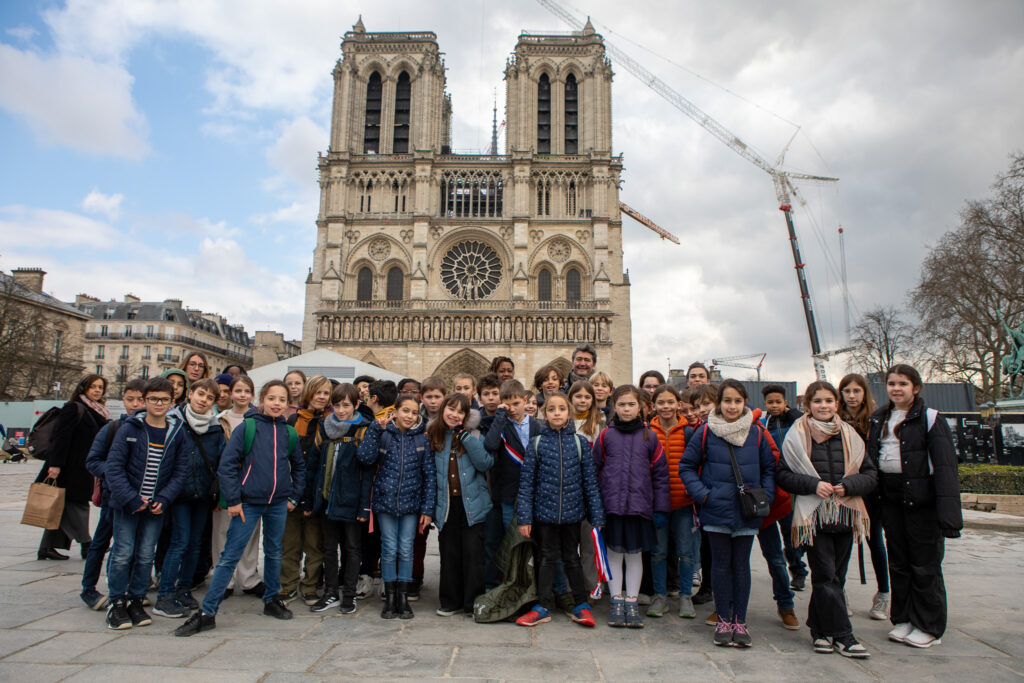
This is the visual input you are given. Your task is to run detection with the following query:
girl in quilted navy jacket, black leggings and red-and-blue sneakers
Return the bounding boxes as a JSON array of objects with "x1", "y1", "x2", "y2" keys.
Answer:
[{"x1": 516, "y1": 392, "x2": 604, "y2": 627}]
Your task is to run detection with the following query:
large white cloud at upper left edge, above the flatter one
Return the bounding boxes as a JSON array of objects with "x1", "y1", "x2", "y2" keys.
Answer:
[{"x1": 0, "y1": 44, "x2": 150, "y2": 159}]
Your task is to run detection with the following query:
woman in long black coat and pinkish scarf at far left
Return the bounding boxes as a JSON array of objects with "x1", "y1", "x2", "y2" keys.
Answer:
[{"x1": 36, "y1": 375, "x2": 110, "y2": 560}]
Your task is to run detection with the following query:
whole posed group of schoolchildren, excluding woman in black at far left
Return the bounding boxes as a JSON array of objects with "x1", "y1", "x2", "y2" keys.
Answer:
[{"x1": 74, "y1": 345, "x2": 963, "y2": 657}]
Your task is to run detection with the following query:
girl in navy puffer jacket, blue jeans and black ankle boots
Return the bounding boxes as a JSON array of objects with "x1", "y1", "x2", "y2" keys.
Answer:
[{"x1": 358, "y1": 394, "x2": 437, "y2": 618}]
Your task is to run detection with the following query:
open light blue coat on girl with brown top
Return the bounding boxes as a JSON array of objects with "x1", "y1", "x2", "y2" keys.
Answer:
[{"x1": 432, "y1": 429, "x2": 495, "y2": 530}]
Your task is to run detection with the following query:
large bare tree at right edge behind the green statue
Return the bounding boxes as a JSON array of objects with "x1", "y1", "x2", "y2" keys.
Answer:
[{"x1": 910, "y1": 154, "x2": 1024, "y2": 399}]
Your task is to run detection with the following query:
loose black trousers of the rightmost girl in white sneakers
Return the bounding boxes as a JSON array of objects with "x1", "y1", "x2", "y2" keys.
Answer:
[{"x1": 882, "y1": 499, "x2": 946, "y2": 638}]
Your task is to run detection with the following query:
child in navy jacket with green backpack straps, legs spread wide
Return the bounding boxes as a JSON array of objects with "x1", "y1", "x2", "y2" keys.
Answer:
[{"x1": 174, "y1": 380, "x2": 306, "y2": 636}]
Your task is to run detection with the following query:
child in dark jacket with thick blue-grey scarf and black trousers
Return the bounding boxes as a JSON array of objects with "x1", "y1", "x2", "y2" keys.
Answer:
[{"x1": 309, "y1": 384, "x2": 374, "y2": 614}]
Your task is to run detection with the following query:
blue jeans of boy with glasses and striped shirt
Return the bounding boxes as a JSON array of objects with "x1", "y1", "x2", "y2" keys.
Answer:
[{"x1": 106, "y1": 510, "x2": 164, "y2": 600}]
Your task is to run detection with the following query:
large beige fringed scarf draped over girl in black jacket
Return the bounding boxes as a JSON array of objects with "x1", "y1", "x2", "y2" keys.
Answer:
[{"x1": 782, "y1": 415, "x2": 869, "y2": 546}]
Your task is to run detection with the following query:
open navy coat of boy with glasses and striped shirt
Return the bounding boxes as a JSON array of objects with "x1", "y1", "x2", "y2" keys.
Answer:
[{"x1": 103, "y1": 411, "x2": 188, "y2": 514}]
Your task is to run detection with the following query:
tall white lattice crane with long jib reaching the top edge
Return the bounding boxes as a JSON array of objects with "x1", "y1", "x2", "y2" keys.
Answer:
[{"x1": 537, "y1": 0, "x2": 839, "y2": 380}]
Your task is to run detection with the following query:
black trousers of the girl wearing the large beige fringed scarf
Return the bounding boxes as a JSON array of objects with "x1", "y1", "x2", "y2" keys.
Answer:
[{"x1": 804, "y1": 531, "x2": 853, "y2": 638}]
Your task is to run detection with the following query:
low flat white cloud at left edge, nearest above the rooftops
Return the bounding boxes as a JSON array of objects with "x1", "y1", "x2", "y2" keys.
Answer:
[{"x1": 0, "y1": 205, "x2": 120, "y2": 252}]
